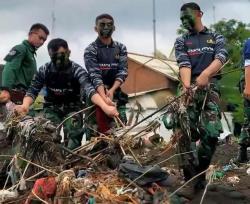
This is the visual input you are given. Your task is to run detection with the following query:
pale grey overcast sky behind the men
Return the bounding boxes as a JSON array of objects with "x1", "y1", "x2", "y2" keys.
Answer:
[{"x1": 0, "y1": 0, "x2": 250, "y2": 66}]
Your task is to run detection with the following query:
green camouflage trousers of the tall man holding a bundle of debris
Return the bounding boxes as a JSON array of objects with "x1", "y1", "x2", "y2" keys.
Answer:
[{"x1": 174, "y1": 81, "x2": 222, "y2": 179}]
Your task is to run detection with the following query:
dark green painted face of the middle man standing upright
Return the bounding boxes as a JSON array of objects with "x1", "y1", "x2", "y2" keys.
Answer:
[{"x1": 96, "y1": 18, "x2": 114, "y2": 38}]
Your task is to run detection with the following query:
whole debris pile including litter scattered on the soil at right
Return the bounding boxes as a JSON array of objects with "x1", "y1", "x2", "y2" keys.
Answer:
[{"x1": 0, "y1": 97, "x2": 249, "y2": 204}]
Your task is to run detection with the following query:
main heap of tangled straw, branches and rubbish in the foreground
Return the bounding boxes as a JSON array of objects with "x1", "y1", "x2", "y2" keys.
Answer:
[{"x1": 0, "y1": 111, "x2": 180, "y2": 204}]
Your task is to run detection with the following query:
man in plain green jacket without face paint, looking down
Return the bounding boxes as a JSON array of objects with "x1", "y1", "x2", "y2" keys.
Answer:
[{"x1": 0, "y1": 23, "x2": 49, "y2": 104}]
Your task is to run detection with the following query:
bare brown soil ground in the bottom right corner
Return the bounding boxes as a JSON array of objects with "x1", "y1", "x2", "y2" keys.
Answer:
[{"x1": 169, "y1": 142, "x2": 250, "y2": 204}]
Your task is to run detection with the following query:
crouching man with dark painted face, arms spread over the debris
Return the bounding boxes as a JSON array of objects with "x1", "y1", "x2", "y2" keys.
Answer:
[{"x1": 15, "y1": 38, "x2": 118, "y2": 149}]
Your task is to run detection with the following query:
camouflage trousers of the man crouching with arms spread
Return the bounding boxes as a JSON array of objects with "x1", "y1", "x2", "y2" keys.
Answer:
[{"x1": 43, "y1": 105, "x2": 84, "y2": 149}]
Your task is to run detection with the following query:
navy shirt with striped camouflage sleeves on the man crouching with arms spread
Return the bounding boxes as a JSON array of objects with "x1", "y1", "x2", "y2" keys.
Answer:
[{"x1": 26, "y1": 61, "x2": 95, "y2": 104}]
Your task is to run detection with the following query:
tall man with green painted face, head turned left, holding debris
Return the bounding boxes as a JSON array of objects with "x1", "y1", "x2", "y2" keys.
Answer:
[{"x1": 174, "y1": 3, "x2": 228, "y2": 193}]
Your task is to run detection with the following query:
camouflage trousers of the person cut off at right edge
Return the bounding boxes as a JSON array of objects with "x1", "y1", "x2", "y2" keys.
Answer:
[{"x1": 239, "y1": 99, "x2": 250, "y2": 147}]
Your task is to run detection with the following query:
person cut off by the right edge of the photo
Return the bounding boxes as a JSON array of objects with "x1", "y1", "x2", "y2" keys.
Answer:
[{"x1": 238, "y1": 38, "x2": 250, "y2": 163}]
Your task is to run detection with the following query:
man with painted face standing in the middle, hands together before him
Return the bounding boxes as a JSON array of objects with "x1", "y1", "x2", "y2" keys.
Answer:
[{"x1": 84, "y1": 14, "x2": 128, "y2": 137}]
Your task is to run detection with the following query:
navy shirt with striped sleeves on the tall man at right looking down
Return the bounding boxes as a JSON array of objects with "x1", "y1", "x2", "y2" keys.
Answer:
[{"x1": 175, "y1": 27, "x2": 228, "y2": 76}]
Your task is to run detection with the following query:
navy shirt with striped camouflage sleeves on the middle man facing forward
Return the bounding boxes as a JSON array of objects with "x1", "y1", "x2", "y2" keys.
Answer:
[{"x1": 84, "y1": 38, "x2": 128, "y2": 89}]
